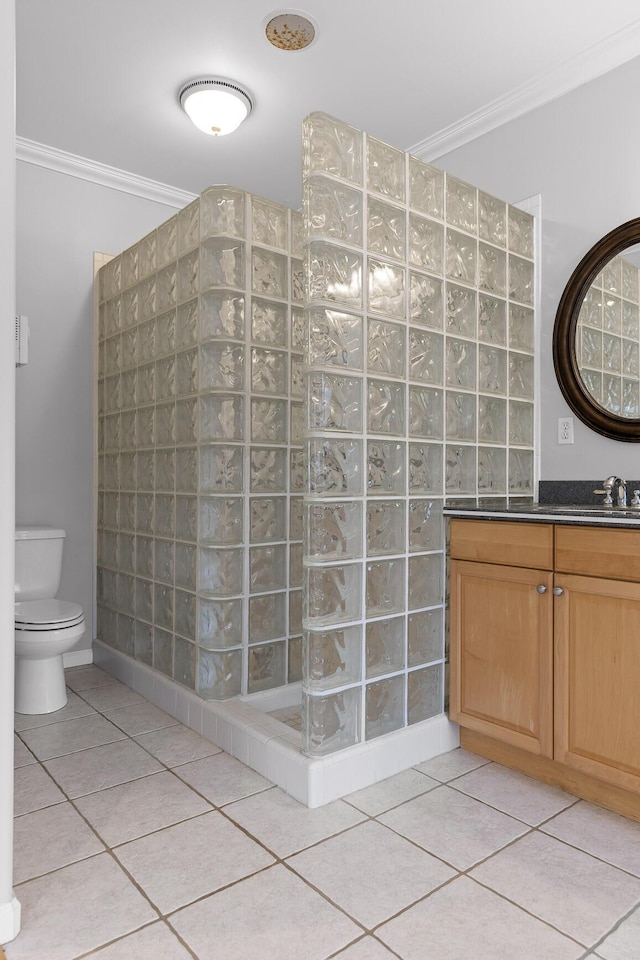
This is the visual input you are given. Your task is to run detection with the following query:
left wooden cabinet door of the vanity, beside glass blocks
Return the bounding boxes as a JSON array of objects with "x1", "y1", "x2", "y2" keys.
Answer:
[{"x1": 450, "y1": 560, "x2": 553, "y2": 757}]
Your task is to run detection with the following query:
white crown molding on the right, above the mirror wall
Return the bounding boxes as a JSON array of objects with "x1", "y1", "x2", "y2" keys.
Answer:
[{"x1": 408, "y1": 20, "x2": 640, "y2": 162}]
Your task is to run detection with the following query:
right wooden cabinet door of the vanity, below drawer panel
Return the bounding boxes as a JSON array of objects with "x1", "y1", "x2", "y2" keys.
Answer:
[{"x1": 555, "y1": 574, "x2": 640, "y2": 791}]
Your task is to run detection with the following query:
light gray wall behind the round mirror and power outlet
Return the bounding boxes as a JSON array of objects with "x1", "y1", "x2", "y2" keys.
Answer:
[{"x1": 432, "y1": 52, "x2": 640, "y2": 480}]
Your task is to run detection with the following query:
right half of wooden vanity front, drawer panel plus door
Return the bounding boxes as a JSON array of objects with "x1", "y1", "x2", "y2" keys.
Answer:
[{"x1": 554, "y1": 526, "x2": 640, "y2": 793}]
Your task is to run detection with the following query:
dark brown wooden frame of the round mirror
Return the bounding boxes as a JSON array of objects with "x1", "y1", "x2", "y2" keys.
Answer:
[{"x1": 553, "y1": 217, "x2": 640, "y2": 443}]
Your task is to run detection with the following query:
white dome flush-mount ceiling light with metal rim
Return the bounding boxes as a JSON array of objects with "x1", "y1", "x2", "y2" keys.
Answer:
[{"x1": 178, "y1": 77, "x2": 253, "y2": 137}]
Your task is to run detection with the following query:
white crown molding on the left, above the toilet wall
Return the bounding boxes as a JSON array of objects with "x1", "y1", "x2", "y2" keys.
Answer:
[{"x1": 16, "y1": 137, "x2": 196, "y2": 209}]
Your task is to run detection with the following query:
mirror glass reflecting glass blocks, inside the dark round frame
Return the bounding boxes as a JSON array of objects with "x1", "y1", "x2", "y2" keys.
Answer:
[{"x1": 577, "y1": 256, "x2": 640, "y2": 419}]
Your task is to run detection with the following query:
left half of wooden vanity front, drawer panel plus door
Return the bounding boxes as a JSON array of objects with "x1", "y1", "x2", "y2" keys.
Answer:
[{"x1": 449, "y1": 520, "x2": 553, "y2": 757}]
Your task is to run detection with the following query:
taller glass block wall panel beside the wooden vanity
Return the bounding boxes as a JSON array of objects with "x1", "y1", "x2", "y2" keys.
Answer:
[{"x1": 303, "y1": 114, "x2": 534, "y2": 756}]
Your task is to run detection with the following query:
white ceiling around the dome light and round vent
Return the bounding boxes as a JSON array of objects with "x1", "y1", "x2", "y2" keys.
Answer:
[{"x1": 16, "y1": 0, "x2": 640, "y2": 207}]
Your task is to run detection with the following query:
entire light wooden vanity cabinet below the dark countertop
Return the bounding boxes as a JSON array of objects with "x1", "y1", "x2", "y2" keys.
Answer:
[{"x1": 450, "y1": 519, "x2": 640, "y2": 819}]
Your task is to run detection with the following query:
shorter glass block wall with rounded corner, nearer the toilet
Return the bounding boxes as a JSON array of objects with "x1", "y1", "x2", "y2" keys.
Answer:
[{"x1": 98, "y1": 186, "x2": 304, "y2": 700}]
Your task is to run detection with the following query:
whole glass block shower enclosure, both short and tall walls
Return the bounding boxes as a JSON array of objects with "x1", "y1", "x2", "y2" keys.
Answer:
[{"x1": 98, "y1": 114, "x2": 534, "y2": 757}]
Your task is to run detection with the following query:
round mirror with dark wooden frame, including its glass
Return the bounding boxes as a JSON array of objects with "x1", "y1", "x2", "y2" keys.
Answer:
[{"x1": 553, "y1": 218, "x2": 640, "y2": 443}]
